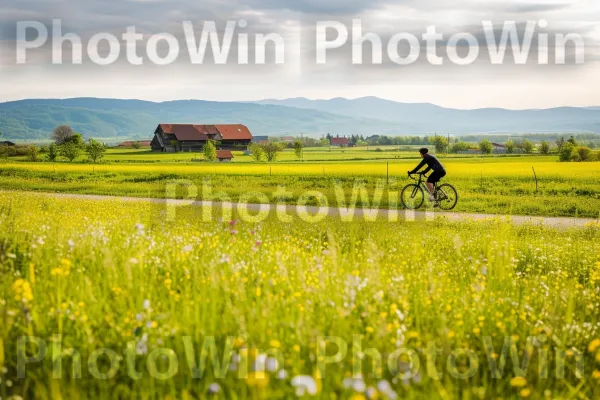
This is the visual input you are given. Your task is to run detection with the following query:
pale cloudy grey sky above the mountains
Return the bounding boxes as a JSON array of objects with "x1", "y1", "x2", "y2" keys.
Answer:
[{"x1": 0, "y1": 0, "x2": 600, "y2": 109}]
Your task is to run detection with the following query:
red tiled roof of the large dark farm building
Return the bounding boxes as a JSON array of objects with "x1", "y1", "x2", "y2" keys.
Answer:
[{"x1": 159, "y1": 124, "x2": 252, "y2": 142}]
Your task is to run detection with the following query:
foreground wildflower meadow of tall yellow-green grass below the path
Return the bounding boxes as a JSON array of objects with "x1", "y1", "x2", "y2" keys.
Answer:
[{"x1": 0, "y1": 193, "x2": 600, "y2": 399}]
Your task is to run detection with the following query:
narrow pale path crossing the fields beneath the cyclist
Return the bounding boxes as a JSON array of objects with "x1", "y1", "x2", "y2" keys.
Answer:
[{"x1": 7, "y1": 192, "x2": 600, "y2": 228}]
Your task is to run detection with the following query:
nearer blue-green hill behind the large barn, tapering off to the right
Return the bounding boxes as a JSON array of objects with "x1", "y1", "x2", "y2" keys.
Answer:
[{"x1": 0, "y1": 98, "x2": 411, "y2": 139}]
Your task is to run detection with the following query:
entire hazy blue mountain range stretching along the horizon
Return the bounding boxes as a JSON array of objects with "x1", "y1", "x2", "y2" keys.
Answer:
[{"x1": 0, "y1": 97, "x2": 600, "y2": 140}]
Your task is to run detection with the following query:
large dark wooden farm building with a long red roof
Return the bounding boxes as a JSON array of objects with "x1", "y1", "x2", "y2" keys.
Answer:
[{"x1": 152, "y1": 124, "x2": 252, "y2": 153}]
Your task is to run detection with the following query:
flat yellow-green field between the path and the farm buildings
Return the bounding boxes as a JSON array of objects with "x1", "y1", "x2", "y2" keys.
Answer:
[{"x1": 0, "y1": 153, "x2": 600, "y2": 218}]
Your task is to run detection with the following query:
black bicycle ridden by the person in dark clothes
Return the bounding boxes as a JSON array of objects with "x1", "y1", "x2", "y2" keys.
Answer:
[{"x1": 400, "y1": 172, "x2": 458, "y2": 211}]
